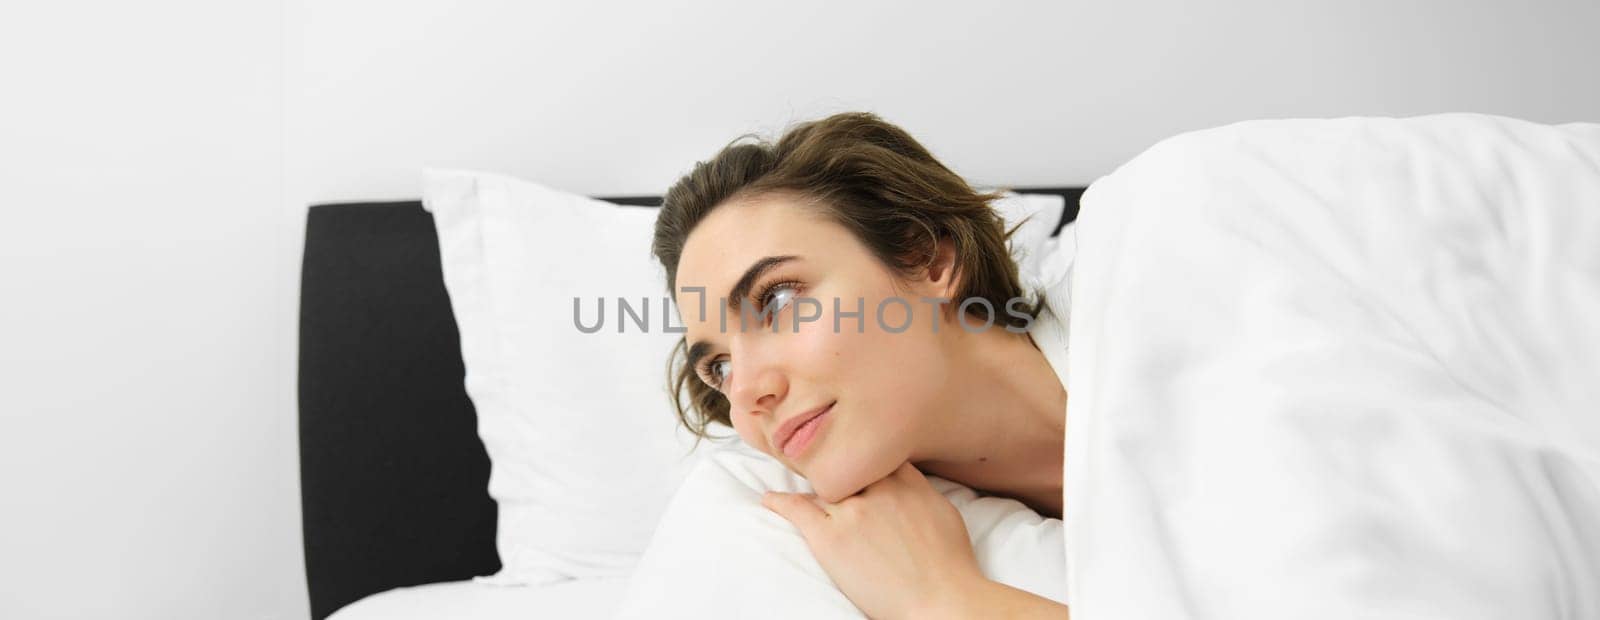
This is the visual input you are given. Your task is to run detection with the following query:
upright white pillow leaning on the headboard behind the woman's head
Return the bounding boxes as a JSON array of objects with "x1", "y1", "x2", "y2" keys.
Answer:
[{"x1": 422, "y1": 169, "x2": 1064, "y2": 585}]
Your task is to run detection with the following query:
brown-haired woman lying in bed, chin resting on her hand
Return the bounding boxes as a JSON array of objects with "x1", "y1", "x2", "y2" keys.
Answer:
[{"x1": 653, "y1": 113, "x2": 1067, "y2": 618}]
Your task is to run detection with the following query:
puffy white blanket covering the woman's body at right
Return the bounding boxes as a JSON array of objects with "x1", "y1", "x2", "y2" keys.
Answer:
[{"x1": 1064, "y1": 115, "x2": 1600, "y2": 620}]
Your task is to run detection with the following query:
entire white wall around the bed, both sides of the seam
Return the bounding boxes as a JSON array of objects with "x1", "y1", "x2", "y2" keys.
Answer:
[{"x1": 0, "y1": 0, "x2": 1600, "y2": 618}]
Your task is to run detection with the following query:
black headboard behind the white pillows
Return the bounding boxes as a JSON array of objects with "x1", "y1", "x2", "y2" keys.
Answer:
[{"x1": 299, "y1": 187, "x2": 1083, "y2": 620}]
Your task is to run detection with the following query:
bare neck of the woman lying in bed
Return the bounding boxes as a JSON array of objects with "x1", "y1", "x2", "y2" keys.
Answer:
[{"x1": 912, "y1": 319, "x2": 1067, "y2": 518}]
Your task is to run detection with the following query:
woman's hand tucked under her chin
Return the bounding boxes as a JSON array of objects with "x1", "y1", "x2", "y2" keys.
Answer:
[{"x1": 762, "y1": 463, "x2": 987, "y2": 618}]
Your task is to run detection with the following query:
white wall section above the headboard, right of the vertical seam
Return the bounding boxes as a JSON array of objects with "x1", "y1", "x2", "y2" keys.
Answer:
[{"x1": 293, "y1": 0, "x2": 1600, "y2": 200}]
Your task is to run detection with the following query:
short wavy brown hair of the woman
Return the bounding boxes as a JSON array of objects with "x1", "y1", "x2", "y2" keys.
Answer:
[{"x1": 651, "y1": 112, "x2": 1043, "y2": 438}]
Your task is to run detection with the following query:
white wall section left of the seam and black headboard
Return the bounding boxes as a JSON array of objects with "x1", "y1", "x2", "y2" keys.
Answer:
[{"x1": 0, "y1": 0, "x2": 307, "y2": 620}]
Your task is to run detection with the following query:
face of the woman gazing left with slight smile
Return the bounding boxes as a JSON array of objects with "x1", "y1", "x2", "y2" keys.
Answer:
[{"x1": 674, "y1": 193, "x2": 950, "y2": 502}]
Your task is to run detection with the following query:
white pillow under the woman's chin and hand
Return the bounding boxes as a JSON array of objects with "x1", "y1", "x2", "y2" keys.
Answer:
[{"x1": 618, "y1": 444, "x2": 1067, "y2": 620}]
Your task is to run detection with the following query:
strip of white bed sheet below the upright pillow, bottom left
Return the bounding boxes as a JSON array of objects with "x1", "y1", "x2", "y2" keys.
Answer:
[{"x1": 328, "y1": 578, "x2": 627, "y2": 620}]
